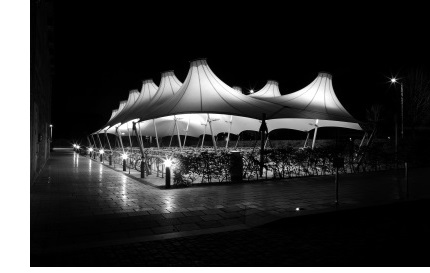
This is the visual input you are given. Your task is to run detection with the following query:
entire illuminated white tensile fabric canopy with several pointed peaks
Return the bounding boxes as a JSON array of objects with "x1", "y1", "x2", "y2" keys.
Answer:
[{"x1": 95, "y1": 59, "x2": 361, "y2": 146}]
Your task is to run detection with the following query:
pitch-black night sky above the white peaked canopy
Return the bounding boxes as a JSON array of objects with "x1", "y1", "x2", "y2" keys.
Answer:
[{"x1": 52, "y1": 1, "x2": 429, "y2": 139}]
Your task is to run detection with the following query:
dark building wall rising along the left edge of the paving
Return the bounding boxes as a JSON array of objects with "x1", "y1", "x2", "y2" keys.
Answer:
[{"x1": 30, "y1": 0, "x2": 54, "y2": 183}]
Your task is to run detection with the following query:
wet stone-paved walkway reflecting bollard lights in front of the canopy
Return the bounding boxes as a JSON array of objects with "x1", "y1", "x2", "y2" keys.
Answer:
[{"x1": 30, "y1": 150, "x2": 430, "y2": 266}]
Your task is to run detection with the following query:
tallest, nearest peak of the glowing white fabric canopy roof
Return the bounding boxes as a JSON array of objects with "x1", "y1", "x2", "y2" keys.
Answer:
[{"x1": 138, "y1": 59, "x2": 290, "y2": 120}]
